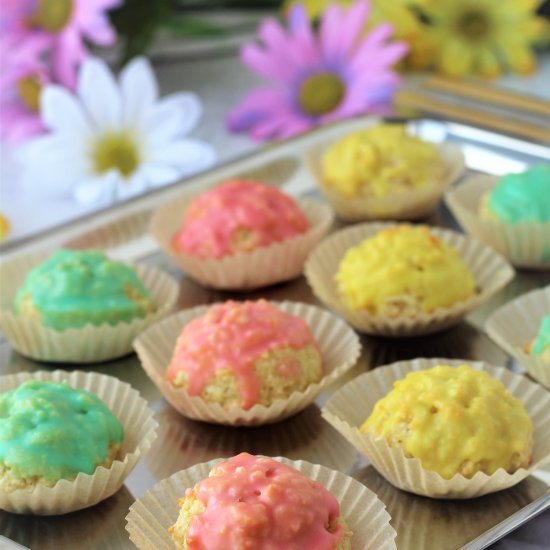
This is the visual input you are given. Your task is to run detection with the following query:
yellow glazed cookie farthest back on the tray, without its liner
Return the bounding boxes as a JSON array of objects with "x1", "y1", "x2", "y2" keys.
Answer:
[{"x1": 322, "y1": 124, "x2": 445, "y2": 197}]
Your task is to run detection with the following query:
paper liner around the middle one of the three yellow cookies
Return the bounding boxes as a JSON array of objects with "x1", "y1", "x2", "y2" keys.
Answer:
[{"x1": 304, "y1": 223, "x2": 514, "y2": 337}]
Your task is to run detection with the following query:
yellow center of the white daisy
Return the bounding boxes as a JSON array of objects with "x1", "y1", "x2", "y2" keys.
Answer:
[{"x1": 92, "y1": 132, "x2": 139, "y2": 178}]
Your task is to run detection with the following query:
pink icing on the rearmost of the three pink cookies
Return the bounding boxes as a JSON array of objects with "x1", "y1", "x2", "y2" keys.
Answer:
[{"x1": 172, "y1": 180, "x2": 309, "y2": 258}]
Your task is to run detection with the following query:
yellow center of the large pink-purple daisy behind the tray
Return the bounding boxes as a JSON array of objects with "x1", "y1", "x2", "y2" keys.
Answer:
[{"x1": 298, "y1": 73, "x2": 346, "y2": 116}]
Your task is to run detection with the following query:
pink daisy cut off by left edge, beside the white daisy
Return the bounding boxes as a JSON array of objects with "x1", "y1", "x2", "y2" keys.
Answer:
[{"x1": 0, "y1": 37, "x2": 50, "y2": 143}]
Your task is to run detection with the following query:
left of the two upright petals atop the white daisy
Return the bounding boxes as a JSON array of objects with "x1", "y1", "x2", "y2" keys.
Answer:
[{"x1": 78, "y1": 58, "x2": 122, "y2": 131}]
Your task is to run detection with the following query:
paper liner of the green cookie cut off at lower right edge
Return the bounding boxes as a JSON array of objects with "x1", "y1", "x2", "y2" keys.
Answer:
[{"x1": 485, "y1": 286, "x2": 550, "y2": 388}]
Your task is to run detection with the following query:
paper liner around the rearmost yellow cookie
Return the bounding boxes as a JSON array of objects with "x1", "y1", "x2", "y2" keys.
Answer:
[{"x1": 304, "y1": 142, "x2": 465, "y2": 221}]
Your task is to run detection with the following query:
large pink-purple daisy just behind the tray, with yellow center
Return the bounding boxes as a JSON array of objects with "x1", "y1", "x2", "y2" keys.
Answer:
[{"x1": 227, "y1": 1, "x2": 407, "y2": 140}]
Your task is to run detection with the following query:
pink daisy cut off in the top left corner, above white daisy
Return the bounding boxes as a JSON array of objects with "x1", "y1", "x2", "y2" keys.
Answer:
[{"x1": 0, "y1": 0, "x2": 122, "y2": 88}]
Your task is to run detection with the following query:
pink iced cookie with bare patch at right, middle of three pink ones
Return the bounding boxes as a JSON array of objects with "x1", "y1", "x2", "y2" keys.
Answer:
[{"x1": 166, "y1": 300, "x2": 323, "y2": 409}]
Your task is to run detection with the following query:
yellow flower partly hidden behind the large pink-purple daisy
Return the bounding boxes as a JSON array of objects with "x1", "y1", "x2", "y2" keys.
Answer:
[{"x1": 283, "y1": 0, "x2": 427, "y2": 42}]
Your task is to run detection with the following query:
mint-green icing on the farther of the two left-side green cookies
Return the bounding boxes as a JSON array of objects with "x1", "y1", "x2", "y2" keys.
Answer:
[{"x1": 14, "y1": 250, "x2": 150, "y2": 330}]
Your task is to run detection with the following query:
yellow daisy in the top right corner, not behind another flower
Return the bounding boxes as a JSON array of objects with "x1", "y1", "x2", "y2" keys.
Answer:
[{"x1": 409, "y1": 0, "x2": 548, "y2": 77}]
